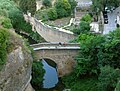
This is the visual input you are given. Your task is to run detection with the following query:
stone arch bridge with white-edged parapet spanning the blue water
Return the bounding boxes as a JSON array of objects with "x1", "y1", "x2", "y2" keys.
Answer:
[{"x1": 31, "y1": 43, "x2": 80, "y2": 77}]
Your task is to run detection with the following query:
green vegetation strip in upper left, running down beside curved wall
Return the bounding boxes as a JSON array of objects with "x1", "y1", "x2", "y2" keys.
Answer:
[{"x1": 0, "y1": 0, "x2": 44, "y2": 42}]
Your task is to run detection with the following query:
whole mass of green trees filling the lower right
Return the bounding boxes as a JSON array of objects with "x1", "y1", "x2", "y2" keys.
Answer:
[{"x1": 63, "y1": 28, "x2": 120, "y2": 91}]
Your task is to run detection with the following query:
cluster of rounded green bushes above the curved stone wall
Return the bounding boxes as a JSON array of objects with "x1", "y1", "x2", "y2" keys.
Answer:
[{"x1": 35, "y1": 0, "x2": 76, "y2": 21}]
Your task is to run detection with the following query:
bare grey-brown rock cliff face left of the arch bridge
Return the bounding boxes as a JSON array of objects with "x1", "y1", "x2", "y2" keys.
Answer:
[{"x1": 0, "y1": 32, "x2": 32, "y2": 91}]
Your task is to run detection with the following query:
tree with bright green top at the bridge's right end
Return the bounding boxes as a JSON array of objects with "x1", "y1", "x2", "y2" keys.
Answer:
[{"x1": 75, "y1": 34, "x2": 105, "y2": 76}]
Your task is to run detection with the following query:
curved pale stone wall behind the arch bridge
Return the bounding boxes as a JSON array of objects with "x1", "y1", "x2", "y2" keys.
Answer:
[{"x1": 24, "y1": 15, "x2": 75, "y2": 42}]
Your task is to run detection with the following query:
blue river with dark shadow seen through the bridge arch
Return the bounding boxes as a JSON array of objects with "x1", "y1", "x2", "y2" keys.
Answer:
[{"x1": 40, "y1": 59, "x2": 64, "y2": 91}]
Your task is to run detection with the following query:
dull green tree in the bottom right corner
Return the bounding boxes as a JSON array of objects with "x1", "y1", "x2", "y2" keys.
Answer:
[{"x1": 97, "y1": 66, "x2": 120, "y2": 91}]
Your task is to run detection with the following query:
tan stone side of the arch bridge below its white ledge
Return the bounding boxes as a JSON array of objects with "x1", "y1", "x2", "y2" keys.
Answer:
[{"x1": 35, "y1": 49, "x2": 79, "y2": 77}]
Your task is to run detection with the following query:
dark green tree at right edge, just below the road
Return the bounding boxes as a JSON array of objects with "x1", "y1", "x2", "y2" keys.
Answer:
[{"x1": 98, "y1": 29, "x2": 120, "y2": 68}]
